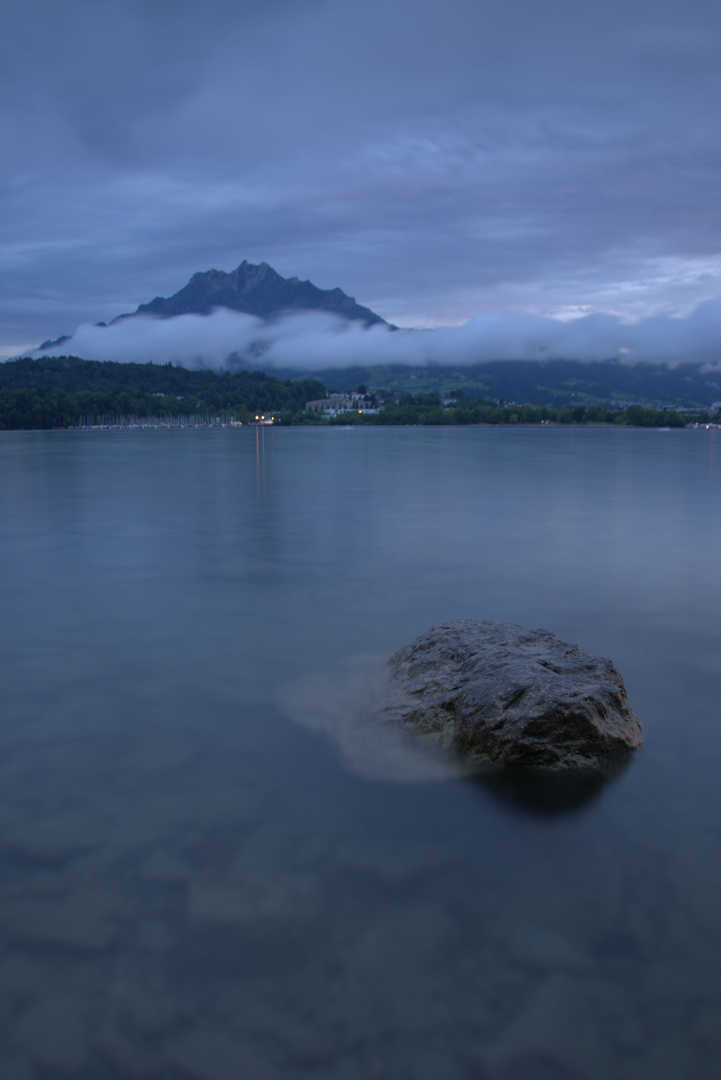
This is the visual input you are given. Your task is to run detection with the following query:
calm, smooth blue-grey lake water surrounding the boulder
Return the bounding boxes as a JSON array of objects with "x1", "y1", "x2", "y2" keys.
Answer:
[{"x1": 0, "y1": 428, "x2": 721, "y2": 1080}]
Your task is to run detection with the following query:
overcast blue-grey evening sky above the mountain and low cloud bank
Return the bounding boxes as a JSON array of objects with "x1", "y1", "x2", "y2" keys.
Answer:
[{"x1": 0, "y1": 0, "x2": 721, "y2": 355}]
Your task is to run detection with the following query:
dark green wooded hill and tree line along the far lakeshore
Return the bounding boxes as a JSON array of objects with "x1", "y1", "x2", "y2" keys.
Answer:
[{"x1": 0, "y1": 356, "x2": 721, "y2": 430}]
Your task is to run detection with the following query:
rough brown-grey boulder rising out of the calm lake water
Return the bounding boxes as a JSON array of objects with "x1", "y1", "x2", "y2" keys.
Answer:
[{"x1": 373, "y1": 619, "x2": 641, "y2": 769}]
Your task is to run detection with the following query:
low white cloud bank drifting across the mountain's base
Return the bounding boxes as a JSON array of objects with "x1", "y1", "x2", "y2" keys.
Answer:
[{"x1": 32, "y1": 300, "x2": 721, "y2": 370}]
